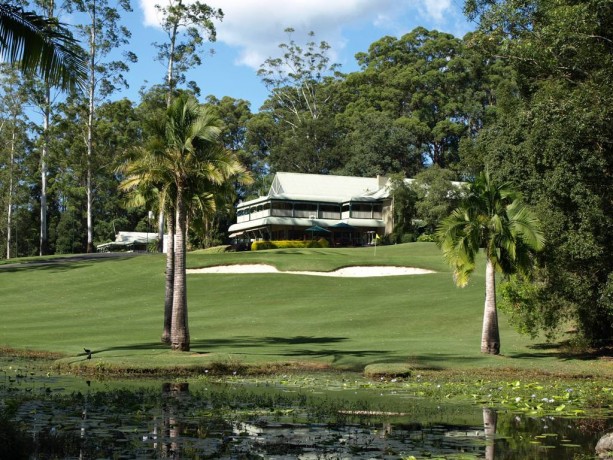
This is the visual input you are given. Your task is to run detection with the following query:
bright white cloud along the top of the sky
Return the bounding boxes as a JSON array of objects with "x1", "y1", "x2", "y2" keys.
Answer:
[{"x1": 140, "y1": 0, "x2": 460, "y2": 69}]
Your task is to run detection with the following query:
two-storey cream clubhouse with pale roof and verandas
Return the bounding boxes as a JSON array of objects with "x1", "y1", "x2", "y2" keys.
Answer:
[{"x1": 229, "y1": 172, "x2": 412, "y2": 246}]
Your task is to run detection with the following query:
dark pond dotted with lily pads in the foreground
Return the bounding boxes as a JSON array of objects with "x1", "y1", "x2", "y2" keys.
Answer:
[{"x1": 0, "y1": 359, "x2": 613, "y2": 459}]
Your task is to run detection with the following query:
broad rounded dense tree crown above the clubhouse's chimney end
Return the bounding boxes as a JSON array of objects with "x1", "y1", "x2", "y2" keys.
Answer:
[{"x1": 344, "y1": 27, "x2": 478, "y2": 167}]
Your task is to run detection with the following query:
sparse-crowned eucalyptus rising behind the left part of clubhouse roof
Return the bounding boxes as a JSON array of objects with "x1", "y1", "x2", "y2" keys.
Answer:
[{"x1": 258, "y1": 28, "x2": 341, "y2": 173}]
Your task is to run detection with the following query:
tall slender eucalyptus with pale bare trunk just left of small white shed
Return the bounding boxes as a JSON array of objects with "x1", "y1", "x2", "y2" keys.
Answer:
[{"x1": 68, "y1": 0, "x2": 137, "y2": 252}]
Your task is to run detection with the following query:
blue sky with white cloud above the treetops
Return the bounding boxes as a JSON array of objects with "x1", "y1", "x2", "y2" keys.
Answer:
[{"x1": 99, "y1": 0, "x2": 474, "y2": 112}]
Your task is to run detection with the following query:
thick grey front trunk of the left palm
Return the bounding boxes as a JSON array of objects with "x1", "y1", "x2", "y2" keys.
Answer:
[{"x1": 170, "y1": 186, "x2": 189, "y2": 351}]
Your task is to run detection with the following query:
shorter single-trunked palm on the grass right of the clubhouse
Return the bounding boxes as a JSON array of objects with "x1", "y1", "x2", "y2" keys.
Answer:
[{"x1": 437, "y1": 171, "x2": 545, "y2": 354}]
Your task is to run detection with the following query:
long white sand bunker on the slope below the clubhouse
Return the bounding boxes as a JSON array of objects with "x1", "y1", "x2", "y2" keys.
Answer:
[{"x1": 187, "y1": 264, "x2": 435, "y2": 278}]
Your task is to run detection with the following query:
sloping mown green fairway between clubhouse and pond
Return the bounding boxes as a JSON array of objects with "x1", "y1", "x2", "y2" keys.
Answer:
[{"x1": 0, "y1": 243, "x2": 612, "y2": 374}]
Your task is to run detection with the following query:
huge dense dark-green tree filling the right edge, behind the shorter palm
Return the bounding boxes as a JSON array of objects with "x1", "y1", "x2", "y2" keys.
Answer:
[{"x1": 466, "y1": 0, "x2": 613, "y2": 347}]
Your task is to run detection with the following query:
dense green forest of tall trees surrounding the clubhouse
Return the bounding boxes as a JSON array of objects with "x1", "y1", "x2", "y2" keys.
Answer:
[{"x1": 0, "y1": 0, "x2": 613, "y2": 345}]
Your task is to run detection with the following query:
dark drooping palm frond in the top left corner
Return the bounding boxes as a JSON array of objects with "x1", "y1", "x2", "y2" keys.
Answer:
[{"x1": 0, "y1": 2, "x2": 86, "y2": 90}]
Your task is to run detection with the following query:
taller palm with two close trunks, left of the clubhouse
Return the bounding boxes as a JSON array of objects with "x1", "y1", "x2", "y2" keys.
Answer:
[{"x1": 122, "y1": 95, "x2": 250, "y2": 351}]
